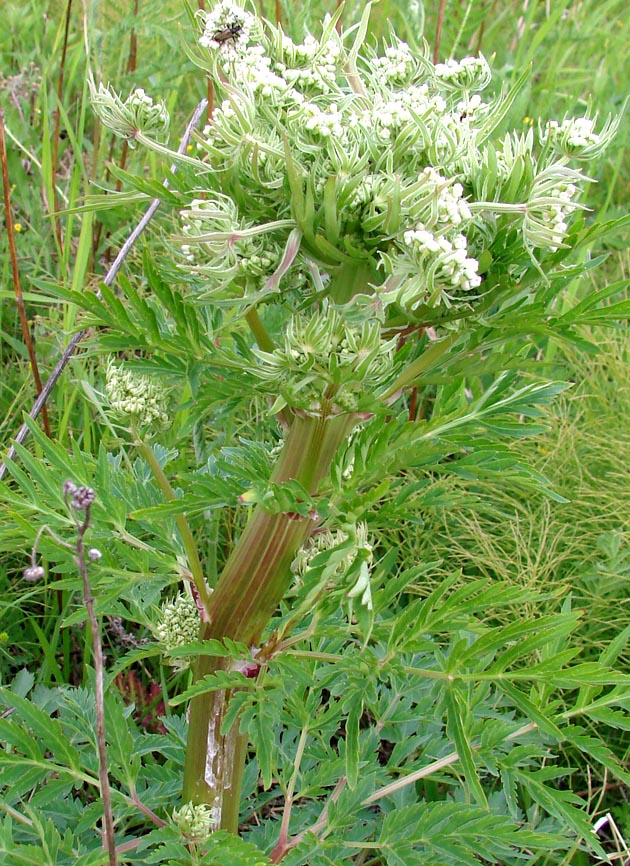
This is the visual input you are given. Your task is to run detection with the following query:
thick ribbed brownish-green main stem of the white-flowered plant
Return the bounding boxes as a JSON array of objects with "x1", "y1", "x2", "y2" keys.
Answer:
[{"x1": 183, "y1": 415, "x2": 356, "y2": 833}]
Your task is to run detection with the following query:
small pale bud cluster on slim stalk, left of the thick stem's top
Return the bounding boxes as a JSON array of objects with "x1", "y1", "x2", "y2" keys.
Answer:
[{"x1": 105, "y1": 360, "x2": 169, "y2": 427}]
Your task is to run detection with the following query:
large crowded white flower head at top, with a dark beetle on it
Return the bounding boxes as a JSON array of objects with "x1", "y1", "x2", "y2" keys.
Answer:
[{"x1": 162, "y1": 0, "x2": 616, "y2": 327}]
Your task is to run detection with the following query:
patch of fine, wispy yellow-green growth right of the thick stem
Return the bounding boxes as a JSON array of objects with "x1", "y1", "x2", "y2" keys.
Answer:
[{"x1": 405, "y1": 320, "x2": 630, "y2": 664}]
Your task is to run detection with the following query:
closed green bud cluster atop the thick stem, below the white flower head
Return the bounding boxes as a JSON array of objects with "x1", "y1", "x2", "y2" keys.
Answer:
[{"x1": 253, "y1": 307, "x2": 396, "y2": 414}]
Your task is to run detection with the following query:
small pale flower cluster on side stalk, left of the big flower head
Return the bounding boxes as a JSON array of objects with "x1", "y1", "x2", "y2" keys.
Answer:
[{"x1": 90, "y1": 82, "x2": 170, "y2": 147}]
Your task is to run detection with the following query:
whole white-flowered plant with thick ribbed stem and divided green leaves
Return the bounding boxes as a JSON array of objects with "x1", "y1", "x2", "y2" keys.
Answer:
[{"x1": 0, "y1": 0, "x2": 628, "y2": 866}]
